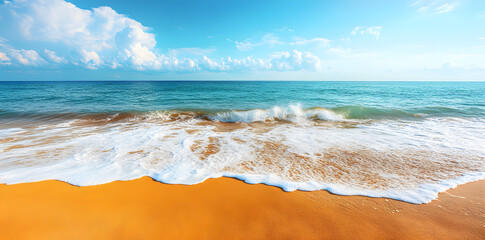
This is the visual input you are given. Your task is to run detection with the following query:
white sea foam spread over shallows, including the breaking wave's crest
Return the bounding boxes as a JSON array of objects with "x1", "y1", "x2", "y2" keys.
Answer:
[{"x1": 0, "y1": 115, "x2": 485, "y2": 203}]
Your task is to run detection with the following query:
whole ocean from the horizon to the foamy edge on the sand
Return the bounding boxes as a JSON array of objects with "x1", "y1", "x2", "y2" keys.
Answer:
[{"x1": 0, "y1": 81, "x2": 485, "y2": 203}]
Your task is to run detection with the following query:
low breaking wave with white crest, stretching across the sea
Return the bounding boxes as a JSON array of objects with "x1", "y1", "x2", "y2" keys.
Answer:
[{"x1": 0, "y1": 104, "x2": 483, "y2": 124}]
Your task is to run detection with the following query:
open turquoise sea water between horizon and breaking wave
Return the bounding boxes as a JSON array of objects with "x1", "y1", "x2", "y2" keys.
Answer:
[{"x1": 0, "y1": 82, "x2": 485, "y2": 118}]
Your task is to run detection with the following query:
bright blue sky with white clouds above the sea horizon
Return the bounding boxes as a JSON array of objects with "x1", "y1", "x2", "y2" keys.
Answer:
[{"x1": 0, "y1": 0, "x2": 485, "y2": 81}]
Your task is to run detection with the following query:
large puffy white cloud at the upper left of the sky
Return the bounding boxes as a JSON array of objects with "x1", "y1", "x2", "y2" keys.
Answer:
[{"x1": 0, "y1": 0, "x2": 158, "y2": 69}]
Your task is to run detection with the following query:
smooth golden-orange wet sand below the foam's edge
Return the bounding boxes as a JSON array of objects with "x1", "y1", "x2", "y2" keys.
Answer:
[{"x1": 0, "y1": 177, "x2": 485, "y2": 239}]
